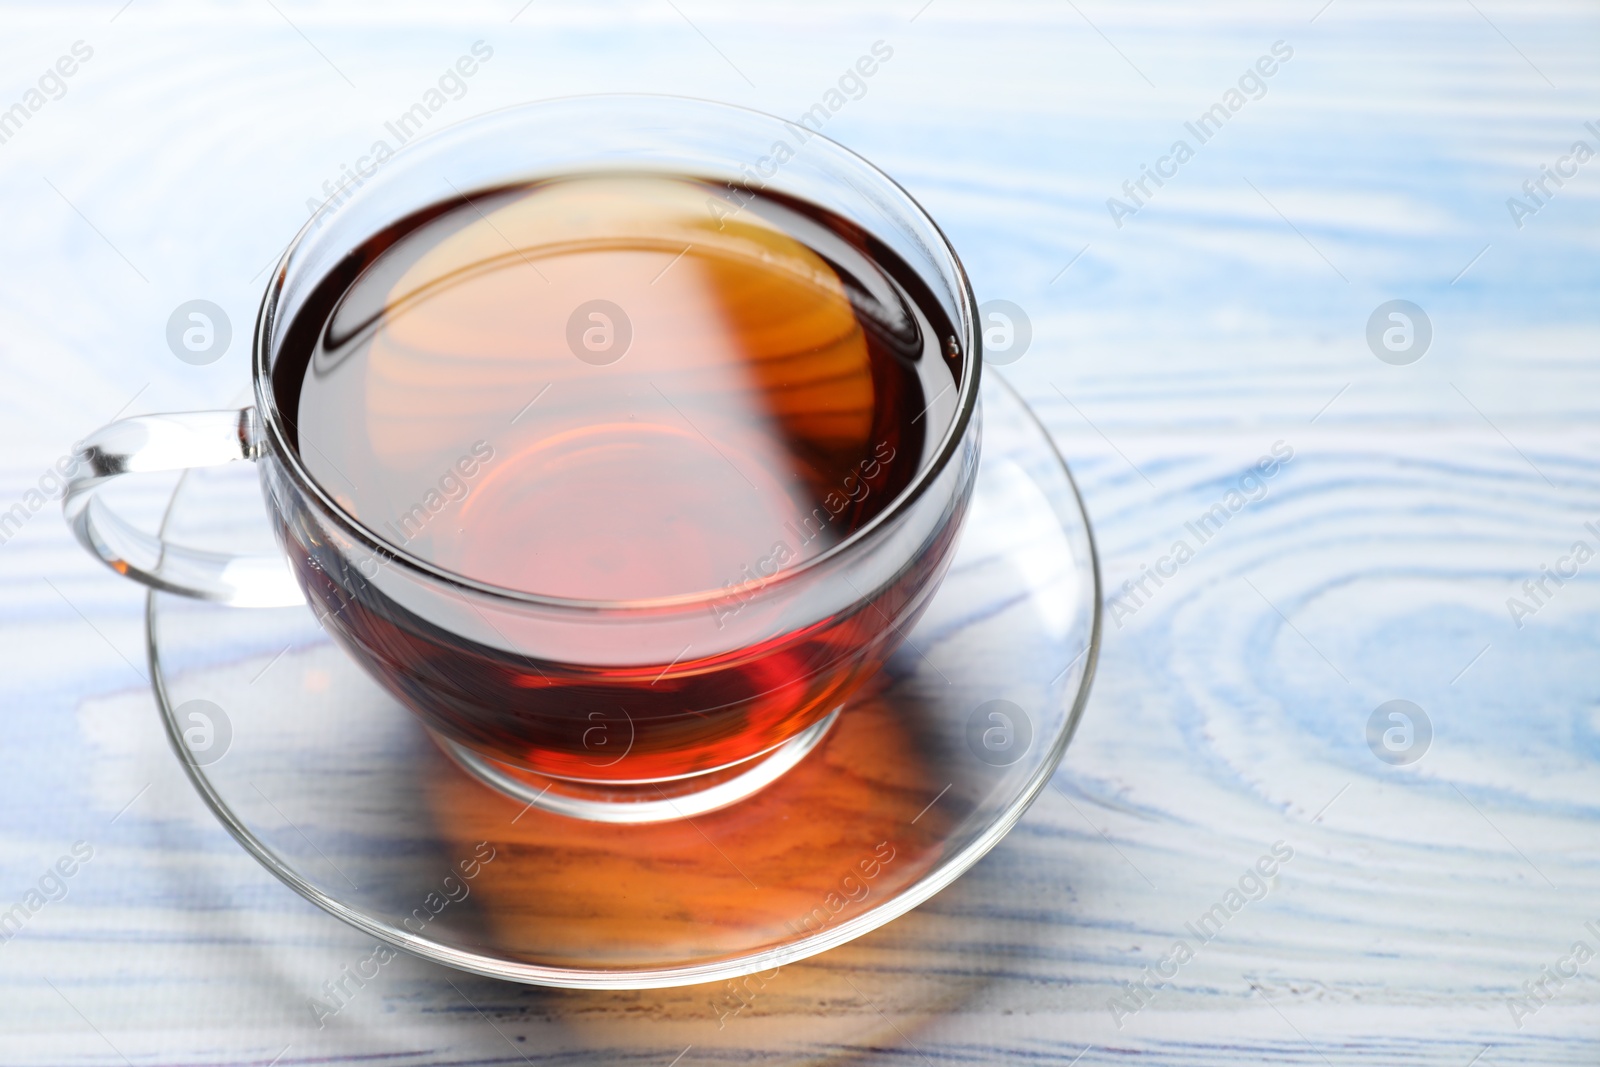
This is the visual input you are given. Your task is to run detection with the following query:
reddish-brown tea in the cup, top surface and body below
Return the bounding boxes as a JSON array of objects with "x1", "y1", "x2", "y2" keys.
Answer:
[{"x1": 272, "y1": 174, "x2": 958, "y2": 779}]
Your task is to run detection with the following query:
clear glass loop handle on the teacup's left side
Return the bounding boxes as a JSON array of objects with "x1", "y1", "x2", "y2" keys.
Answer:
[{"x1": 61, "y1": 408, "x2": 306, "y2": 608}]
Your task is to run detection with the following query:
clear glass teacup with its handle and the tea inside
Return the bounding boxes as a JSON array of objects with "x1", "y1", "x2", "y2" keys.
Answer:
[{"x1": 64, "y1": 96, "x2": 981, "y2": 822}]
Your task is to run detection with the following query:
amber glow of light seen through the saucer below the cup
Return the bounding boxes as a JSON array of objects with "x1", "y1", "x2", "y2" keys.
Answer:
[{"x1": 429, "y1": 681, "x2": 958, "y2": 968}]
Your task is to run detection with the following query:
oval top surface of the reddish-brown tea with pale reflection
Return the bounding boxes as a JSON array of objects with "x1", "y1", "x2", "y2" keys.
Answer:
[{"x1": 274, "y1": 174, "x2": 958, "y2": 600}]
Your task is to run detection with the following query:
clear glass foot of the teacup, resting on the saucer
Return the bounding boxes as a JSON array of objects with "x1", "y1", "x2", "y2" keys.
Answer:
[{"x1": 429, "y1": 707, "x2": 840, "y2": 825}]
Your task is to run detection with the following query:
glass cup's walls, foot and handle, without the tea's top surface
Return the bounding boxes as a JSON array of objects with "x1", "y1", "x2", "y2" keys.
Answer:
[{"x1": 64, "y1": 96, "x2": 981, "y2": 822}]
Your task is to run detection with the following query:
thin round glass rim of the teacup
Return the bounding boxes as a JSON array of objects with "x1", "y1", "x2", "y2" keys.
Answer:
[{"x1": 251, "y1": 93, "x2": 984, "y2": 613}]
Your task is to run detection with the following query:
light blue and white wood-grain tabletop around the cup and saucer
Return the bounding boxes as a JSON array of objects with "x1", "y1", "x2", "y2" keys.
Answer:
[{"x1": 0, "y1": 0, "x2": 1600, "y2": 1067}]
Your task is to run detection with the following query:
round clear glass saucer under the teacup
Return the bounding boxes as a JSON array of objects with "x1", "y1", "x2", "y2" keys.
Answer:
[{"x1": 147, "y1": 370, "x2": 1099, "y2": 989}]
